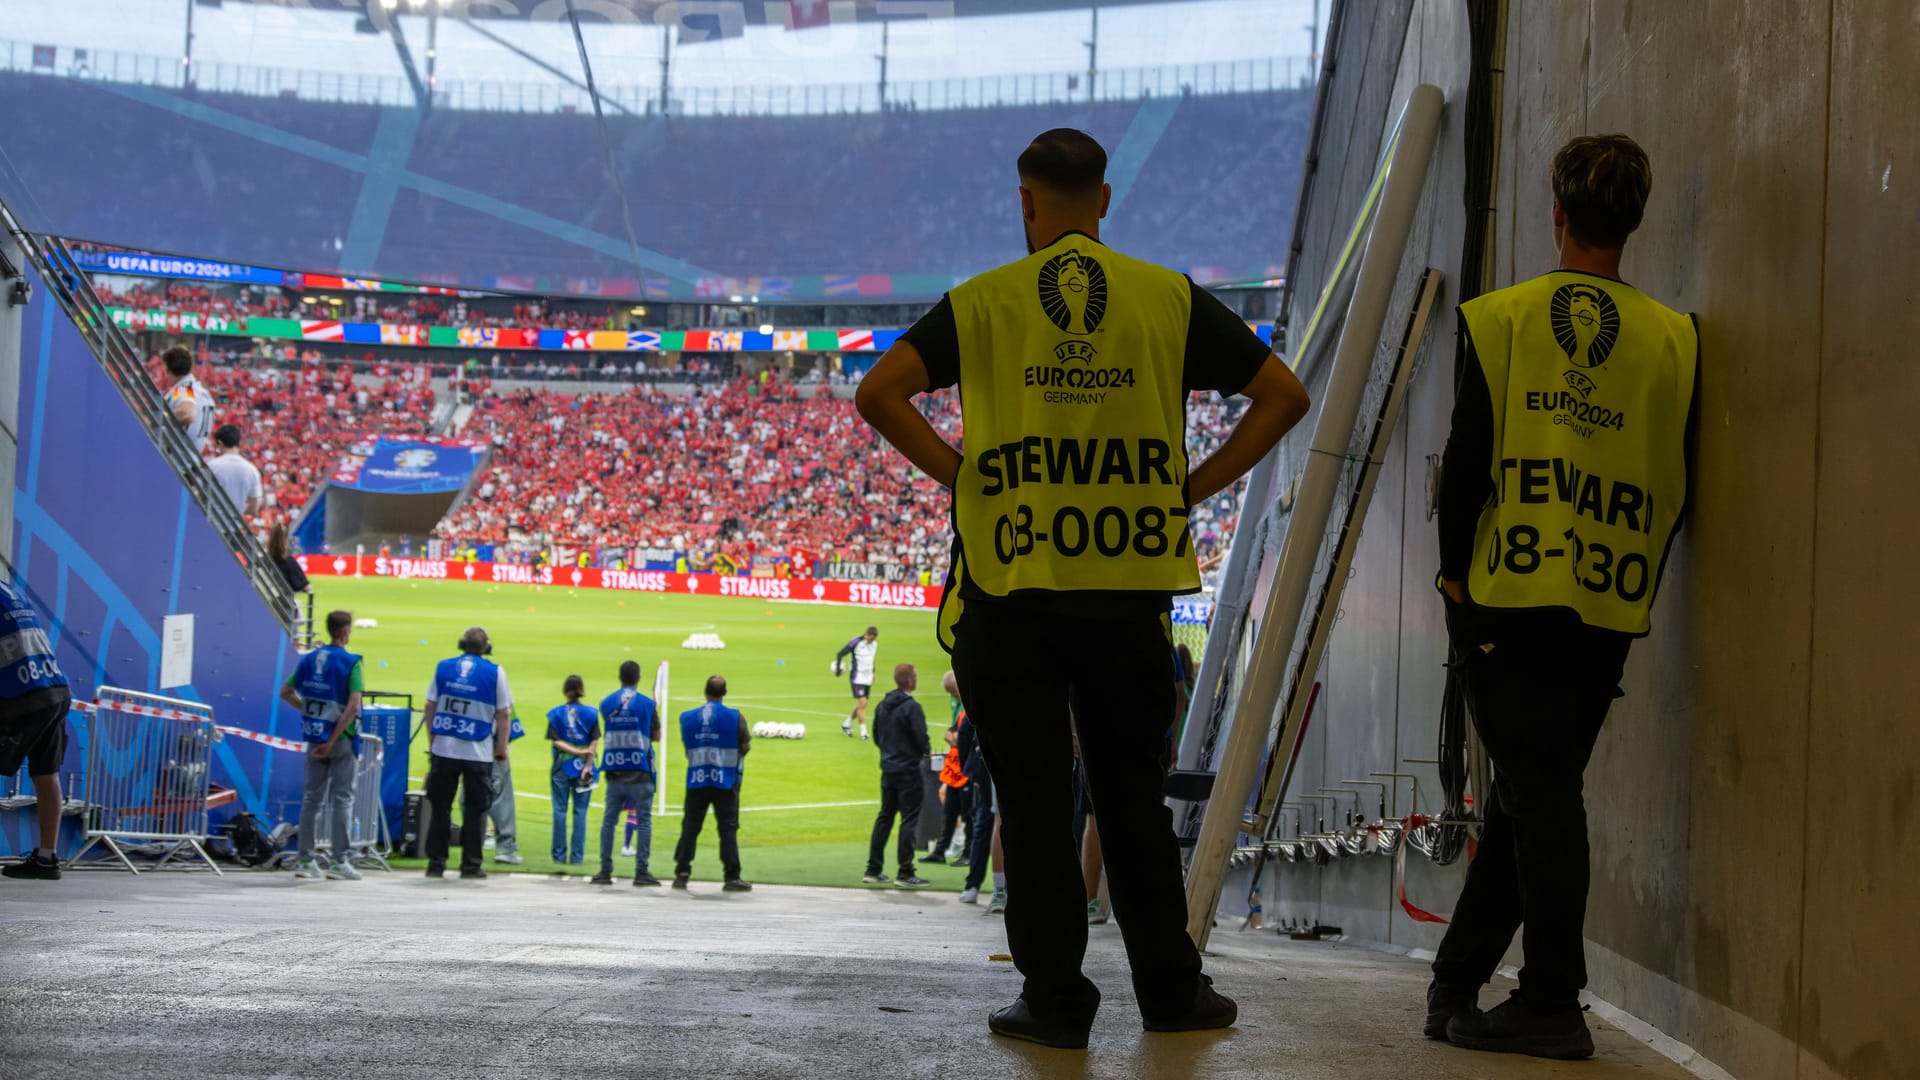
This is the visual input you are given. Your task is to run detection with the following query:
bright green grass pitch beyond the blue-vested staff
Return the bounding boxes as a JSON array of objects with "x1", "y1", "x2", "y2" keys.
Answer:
[{"x1": 313, "y1": 578, "x2": 962, "y2": 890}]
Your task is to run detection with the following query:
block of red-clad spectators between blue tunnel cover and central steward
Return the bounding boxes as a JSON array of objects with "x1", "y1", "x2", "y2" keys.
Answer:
[{"x1": 440, "y1": 368, "x2": 960, "y2": 571}]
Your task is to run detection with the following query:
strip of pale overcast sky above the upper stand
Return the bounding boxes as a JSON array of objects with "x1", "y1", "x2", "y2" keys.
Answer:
[{"x1": 0, "y1": 0, "x2": 1331, "y2": 95}]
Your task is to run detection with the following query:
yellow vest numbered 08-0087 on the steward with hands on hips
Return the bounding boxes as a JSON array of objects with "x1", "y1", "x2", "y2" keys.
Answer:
[{"x1": 948, "y1": 233, "x2": 1200, "y2": 596}]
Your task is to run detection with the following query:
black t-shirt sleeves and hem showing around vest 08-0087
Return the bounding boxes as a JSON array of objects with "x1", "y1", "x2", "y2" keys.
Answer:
[{"x1": 900, "y1": 267, "x2": 1273, "y2": 617}]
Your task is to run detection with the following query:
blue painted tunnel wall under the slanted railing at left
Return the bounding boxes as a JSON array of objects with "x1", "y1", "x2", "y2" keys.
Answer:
[{"x1": 0, "y1": 255, "x2": 301, "y2": 855}]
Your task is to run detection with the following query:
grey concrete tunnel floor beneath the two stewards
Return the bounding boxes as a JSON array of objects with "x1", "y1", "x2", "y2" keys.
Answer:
[{"x1": 0, "y1": 871, "x2": 1686, "y2": 1080}]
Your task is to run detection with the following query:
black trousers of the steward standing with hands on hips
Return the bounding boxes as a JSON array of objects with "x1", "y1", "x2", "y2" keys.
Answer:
[{"x1": 952, "y1": 601, "x2": 1200, "y2": 1024}]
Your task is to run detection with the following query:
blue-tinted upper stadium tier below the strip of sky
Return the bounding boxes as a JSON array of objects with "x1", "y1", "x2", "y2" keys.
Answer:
[{"x1": 0, "y1": 71, "x2": 1309, "y2": 294}]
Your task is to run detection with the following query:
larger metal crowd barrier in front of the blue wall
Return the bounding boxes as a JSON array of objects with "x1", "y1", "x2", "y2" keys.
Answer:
[{"x1": 67, "y1": 686, "x2": 221, "y2": 874}]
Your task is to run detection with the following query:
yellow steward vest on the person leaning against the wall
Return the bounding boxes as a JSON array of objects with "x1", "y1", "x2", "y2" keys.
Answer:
[{"x1": 1461, "y1": 271, "x2": 1699, "y2": 634}]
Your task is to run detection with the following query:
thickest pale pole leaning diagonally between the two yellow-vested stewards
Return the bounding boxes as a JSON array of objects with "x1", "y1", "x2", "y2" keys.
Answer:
[{"x1": 1187, "y1": 85, "x2": 1446, "y2": 947}]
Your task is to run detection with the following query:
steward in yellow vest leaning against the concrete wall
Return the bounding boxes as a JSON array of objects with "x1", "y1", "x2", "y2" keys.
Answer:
[{"x1": 1425, "y1": 135, "x2": 1699, "y2": 1059}]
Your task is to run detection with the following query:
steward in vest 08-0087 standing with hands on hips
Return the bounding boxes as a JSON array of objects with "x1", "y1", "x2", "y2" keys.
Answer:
[{"x1": 854, "y1": 129, "x2": 1308, "y2": 1047}]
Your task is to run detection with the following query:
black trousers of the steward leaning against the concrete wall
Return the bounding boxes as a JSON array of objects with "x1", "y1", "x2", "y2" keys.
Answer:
[{"x1": 1434, "y1": 613, "x2": 1632, "y2": 1011}]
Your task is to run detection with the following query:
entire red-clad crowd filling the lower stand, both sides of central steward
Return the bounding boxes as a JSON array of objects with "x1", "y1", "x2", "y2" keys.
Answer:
[{"x1": 154, "y1": 359, "x2": 1238, "y2": 575}]
